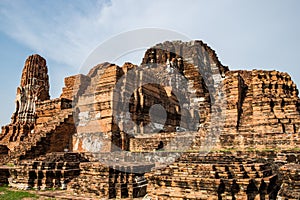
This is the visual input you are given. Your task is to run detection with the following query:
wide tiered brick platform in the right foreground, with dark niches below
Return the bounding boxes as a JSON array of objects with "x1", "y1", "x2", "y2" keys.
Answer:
[{"x1": 147, "y1": 153, "x2": 279, "y2": 199}]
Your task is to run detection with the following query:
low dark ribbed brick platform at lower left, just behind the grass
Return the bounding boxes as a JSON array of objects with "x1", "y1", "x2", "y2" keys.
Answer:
[{"x1": 9, "y1": 153, "x2": 85, "y2": 190}]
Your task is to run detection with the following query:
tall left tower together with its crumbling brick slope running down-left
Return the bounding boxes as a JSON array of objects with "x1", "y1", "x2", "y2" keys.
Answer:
[{"x1": 0, "y1": 54, "x2": 50, "y2": 152}]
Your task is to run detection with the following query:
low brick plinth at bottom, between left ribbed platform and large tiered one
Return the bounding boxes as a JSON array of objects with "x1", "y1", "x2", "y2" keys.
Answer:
[{"x1": 69, "y1": 162, "x2": 152, "y2": 199}]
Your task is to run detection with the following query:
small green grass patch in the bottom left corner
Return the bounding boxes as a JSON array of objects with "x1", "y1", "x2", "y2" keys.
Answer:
[{"x1": 0, "y1": 186, "x2": 38, "y2": 200}]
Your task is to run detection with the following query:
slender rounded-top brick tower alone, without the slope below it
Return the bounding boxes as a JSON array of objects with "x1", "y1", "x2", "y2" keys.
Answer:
[{"x1": 12, "y1": 54, "x2": 50, "y2": 124}]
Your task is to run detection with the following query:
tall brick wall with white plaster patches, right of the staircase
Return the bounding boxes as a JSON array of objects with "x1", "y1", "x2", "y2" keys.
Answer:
[{"x1": 73, "y1": 63, "x2": 122, "y2": 152}]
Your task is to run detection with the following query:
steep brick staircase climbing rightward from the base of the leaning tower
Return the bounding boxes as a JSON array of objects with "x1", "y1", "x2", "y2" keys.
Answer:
[{"x1": 9, "y1": 108, "x2": 73, "y2": 159}]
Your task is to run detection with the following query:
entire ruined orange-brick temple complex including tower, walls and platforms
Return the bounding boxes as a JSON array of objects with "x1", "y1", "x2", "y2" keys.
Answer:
[{"x1": 0, "y1": 41, "x2": 300, "y2": 200}]
